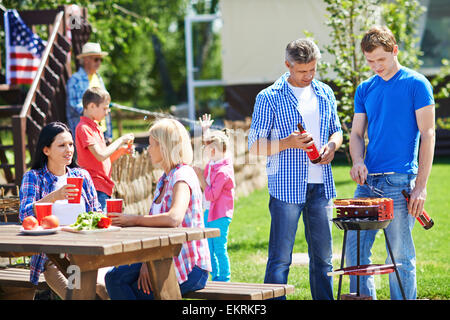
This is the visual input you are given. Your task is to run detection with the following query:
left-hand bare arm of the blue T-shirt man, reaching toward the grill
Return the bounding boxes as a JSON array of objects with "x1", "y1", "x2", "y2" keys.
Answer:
[{"x1": 350, "y1": 113, "x2": 368, "y2": 185}]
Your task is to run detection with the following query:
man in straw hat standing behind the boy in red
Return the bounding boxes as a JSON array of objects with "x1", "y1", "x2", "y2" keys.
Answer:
[{"x1": 66, "y1": 42, "x2": 112, "y2": 142}]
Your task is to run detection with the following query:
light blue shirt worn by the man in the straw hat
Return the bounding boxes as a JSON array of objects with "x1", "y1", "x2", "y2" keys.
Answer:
[{"x1": 66, "y1": 67, "x2": 112, "y2": 138}]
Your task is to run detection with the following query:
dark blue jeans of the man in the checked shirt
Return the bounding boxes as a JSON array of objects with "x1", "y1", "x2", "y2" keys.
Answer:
[{"x1": 264, "y1": 184, "x2": 333, "y2": 300}]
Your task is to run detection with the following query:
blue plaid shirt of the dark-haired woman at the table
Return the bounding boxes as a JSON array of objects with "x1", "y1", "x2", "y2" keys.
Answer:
[{"x1": 19, "y1": 166, "x2": 101, "y2": 285}]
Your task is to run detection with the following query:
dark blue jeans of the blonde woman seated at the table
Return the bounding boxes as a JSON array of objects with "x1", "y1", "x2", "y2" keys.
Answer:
[{"x1": 105, "y1": 263, "x2": 208, "y2": 300}]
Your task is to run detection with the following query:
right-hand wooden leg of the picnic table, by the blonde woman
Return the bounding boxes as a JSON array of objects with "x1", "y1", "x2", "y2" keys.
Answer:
[{"x1": 147, "y1": 258, "x2": 181, "y2": 300}]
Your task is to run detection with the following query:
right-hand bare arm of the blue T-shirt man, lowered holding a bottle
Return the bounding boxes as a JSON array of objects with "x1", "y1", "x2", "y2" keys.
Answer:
[{"x1": 408, "y1": 105, "x2": 435, "y2": 217}]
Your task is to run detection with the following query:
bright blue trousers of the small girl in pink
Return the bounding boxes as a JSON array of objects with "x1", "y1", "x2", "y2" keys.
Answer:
[{"x1": 204, "y1": 210, "x2": 231, "y2": 282}]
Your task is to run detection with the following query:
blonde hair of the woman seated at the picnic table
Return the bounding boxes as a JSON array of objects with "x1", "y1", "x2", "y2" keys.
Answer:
[{"x1": 149, "y1": 119, "x2": 194, "y2": 169}]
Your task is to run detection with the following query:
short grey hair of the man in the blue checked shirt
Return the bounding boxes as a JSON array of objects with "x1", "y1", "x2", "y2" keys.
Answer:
[{"x1": 286, "y1": 39, "x2": 321, "y2": 66}]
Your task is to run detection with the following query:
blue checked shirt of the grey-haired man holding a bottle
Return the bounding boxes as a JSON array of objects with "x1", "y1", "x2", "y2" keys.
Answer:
[{"x1": 248, "y1": 73, "x2": 342, "y2": 203}]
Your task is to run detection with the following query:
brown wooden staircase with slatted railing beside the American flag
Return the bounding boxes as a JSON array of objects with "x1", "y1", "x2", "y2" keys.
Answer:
[{"x1": 0, "y1": 6, "x2": 91, "y2": 194}]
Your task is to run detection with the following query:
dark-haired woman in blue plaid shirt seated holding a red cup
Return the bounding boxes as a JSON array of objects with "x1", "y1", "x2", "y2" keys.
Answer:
[{"x1": 19, "y1": 122, "x2": 108, "y2": 300}]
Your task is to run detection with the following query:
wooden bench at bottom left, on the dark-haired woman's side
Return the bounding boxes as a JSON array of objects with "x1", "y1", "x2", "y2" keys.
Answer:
[{"x1": 0, "y1": 268, "x2": 49, "y2": 300}]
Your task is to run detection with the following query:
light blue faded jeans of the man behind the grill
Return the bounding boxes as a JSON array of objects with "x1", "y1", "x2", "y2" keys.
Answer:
[{"x1": 346, "y1": 173, "x2": 417, "y2": 300}]
